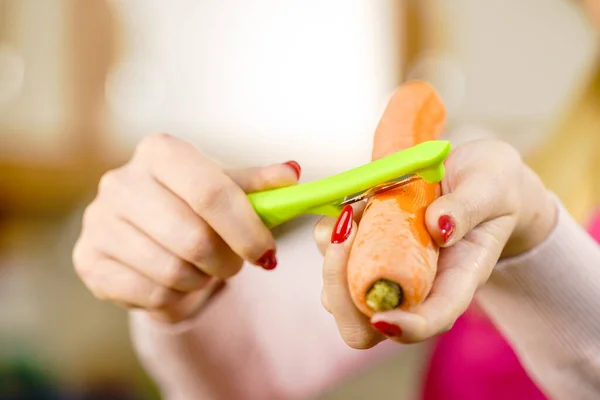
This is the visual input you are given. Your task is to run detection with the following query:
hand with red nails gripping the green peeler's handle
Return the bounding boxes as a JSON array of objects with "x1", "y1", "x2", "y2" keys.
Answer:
[{"x1": 73, "y1": 134, "x2": 300, "y2": 322}]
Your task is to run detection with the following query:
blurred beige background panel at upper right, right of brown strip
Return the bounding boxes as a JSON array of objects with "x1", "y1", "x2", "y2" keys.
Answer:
[{"x1": 424, "y1": 0, "x2": 596, "y2": 149}]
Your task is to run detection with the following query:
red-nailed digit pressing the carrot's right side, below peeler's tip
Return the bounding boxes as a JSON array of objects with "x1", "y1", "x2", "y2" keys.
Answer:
[{"x1": 425, "y1": 147, "x2": 517, "y2": 247}]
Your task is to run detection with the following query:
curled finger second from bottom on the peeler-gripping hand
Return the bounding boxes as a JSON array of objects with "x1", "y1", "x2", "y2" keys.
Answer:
[{"x1": 89, "y1": 214, "x2": 210, "y2": 292}]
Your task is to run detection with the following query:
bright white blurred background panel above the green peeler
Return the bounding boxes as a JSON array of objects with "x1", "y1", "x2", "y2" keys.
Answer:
[{"x1": 107, "y1": 0, "x2": 401, "y2": 170}]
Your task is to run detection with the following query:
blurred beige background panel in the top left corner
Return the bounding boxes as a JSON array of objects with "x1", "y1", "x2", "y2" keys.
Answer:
[{"x1": 0, "y1": 0, "x2": 70, "y2": 154}]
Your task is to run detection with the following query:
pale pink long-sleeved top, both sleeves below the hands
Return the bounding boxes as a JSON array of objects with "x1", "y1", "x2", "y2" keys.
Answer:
[{"x1": 131, "y1": 198, "x2": 600, "y2": 400}]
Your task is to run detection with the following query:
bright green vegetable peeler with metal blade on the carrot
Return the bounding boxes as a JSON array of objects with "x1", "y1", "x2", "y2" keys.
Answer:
[{"x1": 248, "y1": 140, "x2": 451, "y2": 229}]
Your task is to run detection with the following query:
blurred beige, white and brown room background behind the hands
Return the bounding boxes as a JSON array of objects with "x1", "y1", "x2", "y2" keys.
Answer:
[{"x1": 0, "y1": 0, "x2": 595, "y2": 399}]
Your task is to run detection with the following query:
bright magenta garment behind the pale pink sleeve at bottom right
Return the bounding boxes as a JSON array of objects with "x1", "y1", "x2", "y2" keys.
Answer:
[{"x1": 422, "y1": 209, "x2": 600, "y2": 400}]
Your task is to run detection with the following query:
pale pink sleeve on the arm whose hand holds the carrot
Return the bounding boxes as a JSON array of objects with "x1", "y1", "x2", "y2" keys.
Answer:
[{"x1": 478, "y1": 197, "x2": 600, "y2": 400}]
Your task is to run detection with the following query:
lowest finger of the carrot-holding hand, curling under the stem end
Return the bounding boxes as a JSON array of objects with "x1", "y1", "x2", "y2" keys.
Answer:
[{"x1": 372, "y1": 217, "x2": 513, "y2": 343}]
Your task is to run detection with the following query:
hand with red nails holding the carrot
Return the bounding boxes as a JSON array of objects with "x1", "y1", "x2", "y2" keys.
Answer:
[{"x1": 315, "y1": 140, "x2": 556, "y2": 348}]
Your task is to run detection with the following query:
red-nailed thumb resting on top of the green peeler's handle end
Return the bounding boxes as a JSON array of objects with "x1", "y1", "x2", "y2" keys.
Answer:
[{"x1": 226, "y1": 161, "x2": 302, "y2": 193}]
